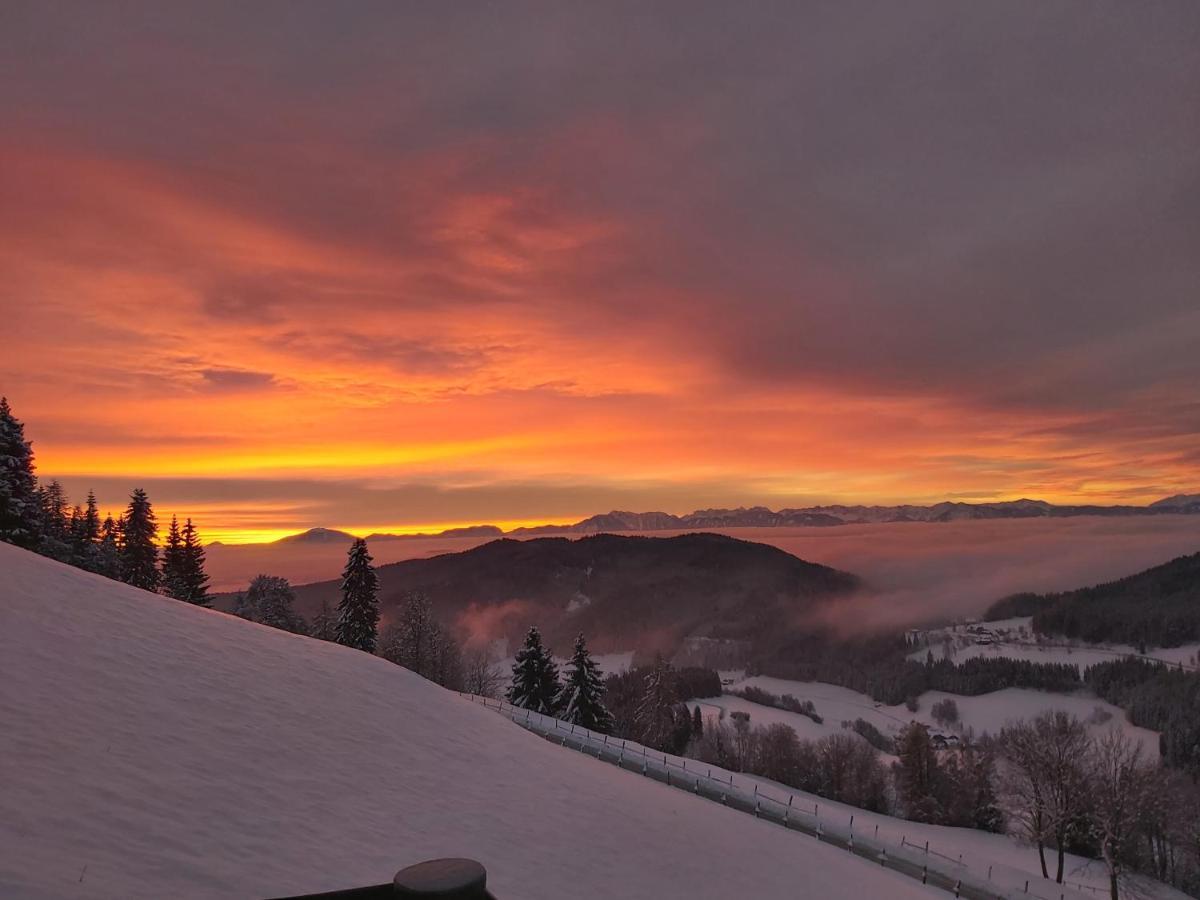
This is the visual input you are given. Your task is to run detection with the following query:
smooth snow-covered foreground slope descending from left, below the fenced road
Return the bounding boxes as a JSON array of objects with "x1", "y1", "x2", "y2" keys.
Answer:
[{"x1": 0, "y1": 544, "x2": 936, "y2": 900}]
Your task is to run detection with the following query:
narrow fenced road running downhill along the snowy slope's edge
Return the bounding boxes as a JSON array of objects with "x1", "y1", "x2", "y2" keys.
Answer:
[{"x1": 462, "y1": 694, "x2": 1094, "y2": 900}]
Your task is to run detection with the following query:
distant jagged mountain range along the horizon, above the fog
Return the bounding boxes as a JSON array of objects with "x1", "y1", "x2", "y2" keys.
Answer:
[{"x1": 243, "y1": 494, "x2": 1200, "y2": 544}]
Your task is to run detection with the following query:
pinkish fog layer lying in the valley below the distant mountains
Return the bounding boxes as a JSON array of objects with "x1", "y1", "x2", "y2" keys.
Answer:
[{"x1": 209, "y1": 515, "x2": 1200, "y2": 630}]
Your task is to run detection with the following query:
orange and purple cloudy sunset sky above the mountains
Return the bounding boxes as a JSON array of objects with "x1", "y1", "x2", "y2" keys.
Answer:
[{"x1": 0, "y1": 0, "x2": 1200, "y2": 540}]
